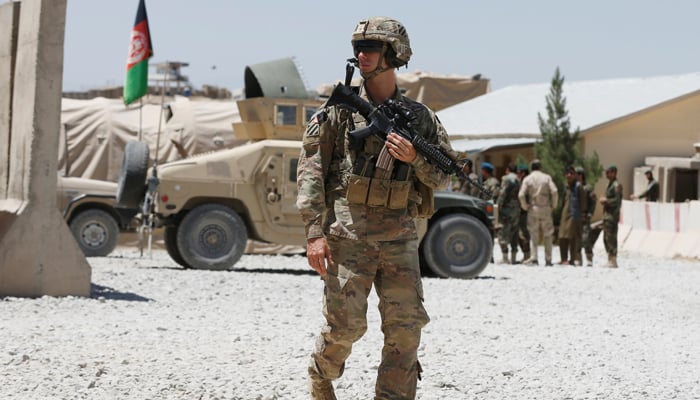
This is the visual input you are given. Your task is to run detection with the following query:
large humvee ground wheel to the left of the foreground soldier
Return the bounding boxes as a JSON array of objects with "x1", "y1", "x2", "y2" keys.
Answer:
[{"x1": 176, "y1": 204, "x2": 248, "y2": 270}]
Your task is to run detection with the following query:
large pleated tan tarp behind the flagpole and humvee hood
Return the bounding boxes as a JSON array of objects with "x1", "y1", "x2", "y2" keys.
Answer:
[{"x1": 58, "y1": 97, "x2": 240, "y2": 182}]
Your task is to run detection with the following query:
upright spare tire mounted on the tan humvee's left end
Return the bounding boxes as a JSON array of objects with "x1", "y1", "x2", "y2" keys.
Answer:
[{"x1": 117, "y1": 140, "x2": 148, "y2": 208}]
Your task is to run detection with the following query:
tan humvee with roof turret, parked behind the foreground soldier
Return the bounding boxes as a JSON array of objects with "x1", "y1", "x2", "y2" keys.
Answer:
[{"x1": 117, "y1": 59, "x2": 493, "y2": 278}]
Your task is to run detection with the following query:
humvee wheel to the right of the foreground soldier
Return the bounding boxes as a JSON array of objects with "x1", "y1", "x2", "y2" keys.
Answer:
[{"x1": 421, "y1": 214, "x2": 493, "y2": 279}]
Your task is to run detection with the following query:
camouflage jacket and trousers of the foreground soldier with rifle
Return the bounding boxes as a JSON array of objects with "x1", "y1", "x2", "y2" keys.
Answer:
[{"x1": 297, "y1": 80, "x2": 449, "y2": 399}]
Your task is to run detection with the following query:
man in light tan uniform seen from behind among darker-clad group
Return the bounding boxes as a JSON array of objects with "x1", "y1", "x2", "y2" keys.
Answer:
[{"x1": 518, "y1": 159, "x2": 559, "y2": 267}]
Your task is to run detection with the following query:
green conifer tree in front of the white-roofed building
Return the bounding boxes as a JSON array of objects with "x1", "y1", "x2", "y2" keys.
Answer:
[{"x1": 535, "y1": 67, "x2": 603, "y2": 219}]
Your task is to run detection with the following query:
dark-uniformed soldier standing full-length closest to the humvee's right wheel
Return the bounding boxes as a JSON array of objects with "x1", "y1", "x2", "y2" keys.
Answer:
[{"x1": 498, "y1": 164, "x2": 520, "y2": 264}]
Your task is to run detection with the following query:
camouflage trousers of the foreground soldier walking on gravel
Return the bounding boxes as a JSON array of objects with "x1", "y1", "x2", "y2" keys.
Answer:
[{"x1": 309, "y1": 236, "x2": 430, "y2": 399}]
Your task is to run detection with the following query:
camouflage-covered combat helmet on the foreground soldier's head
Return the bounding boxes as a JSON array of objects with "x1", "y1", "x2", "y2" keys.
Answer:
[{"x1": 351, "y1": 17, "x2": 413, "y2": 68}]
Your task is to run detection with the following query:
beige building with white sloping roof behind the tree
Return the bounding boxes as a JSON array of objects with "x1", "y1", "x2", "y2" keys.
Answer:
[{"x1": 438, "y1": 73, "x2": 700, "y2": 208}]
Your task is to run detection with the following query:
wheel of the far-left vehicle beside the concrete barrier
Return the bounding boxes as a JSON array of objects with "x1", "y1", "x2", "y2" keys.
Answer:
[{"x1": 69, "y1": 208, "x2": 119, "y2": 257}]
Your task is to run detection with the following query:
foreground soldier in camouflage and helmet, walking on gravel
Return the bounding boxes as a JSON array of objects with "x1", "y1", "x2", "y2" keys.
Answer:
[{"x1": 297, "y1": 17, "x2": 451, "y2": 399}]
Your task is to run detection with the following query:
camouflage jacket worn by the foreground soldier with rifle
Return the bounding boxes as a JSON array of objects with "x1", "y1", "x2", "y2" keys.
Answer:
[{"x1": 296, "y1": 82, "x2": 451, "y2": 241}]
